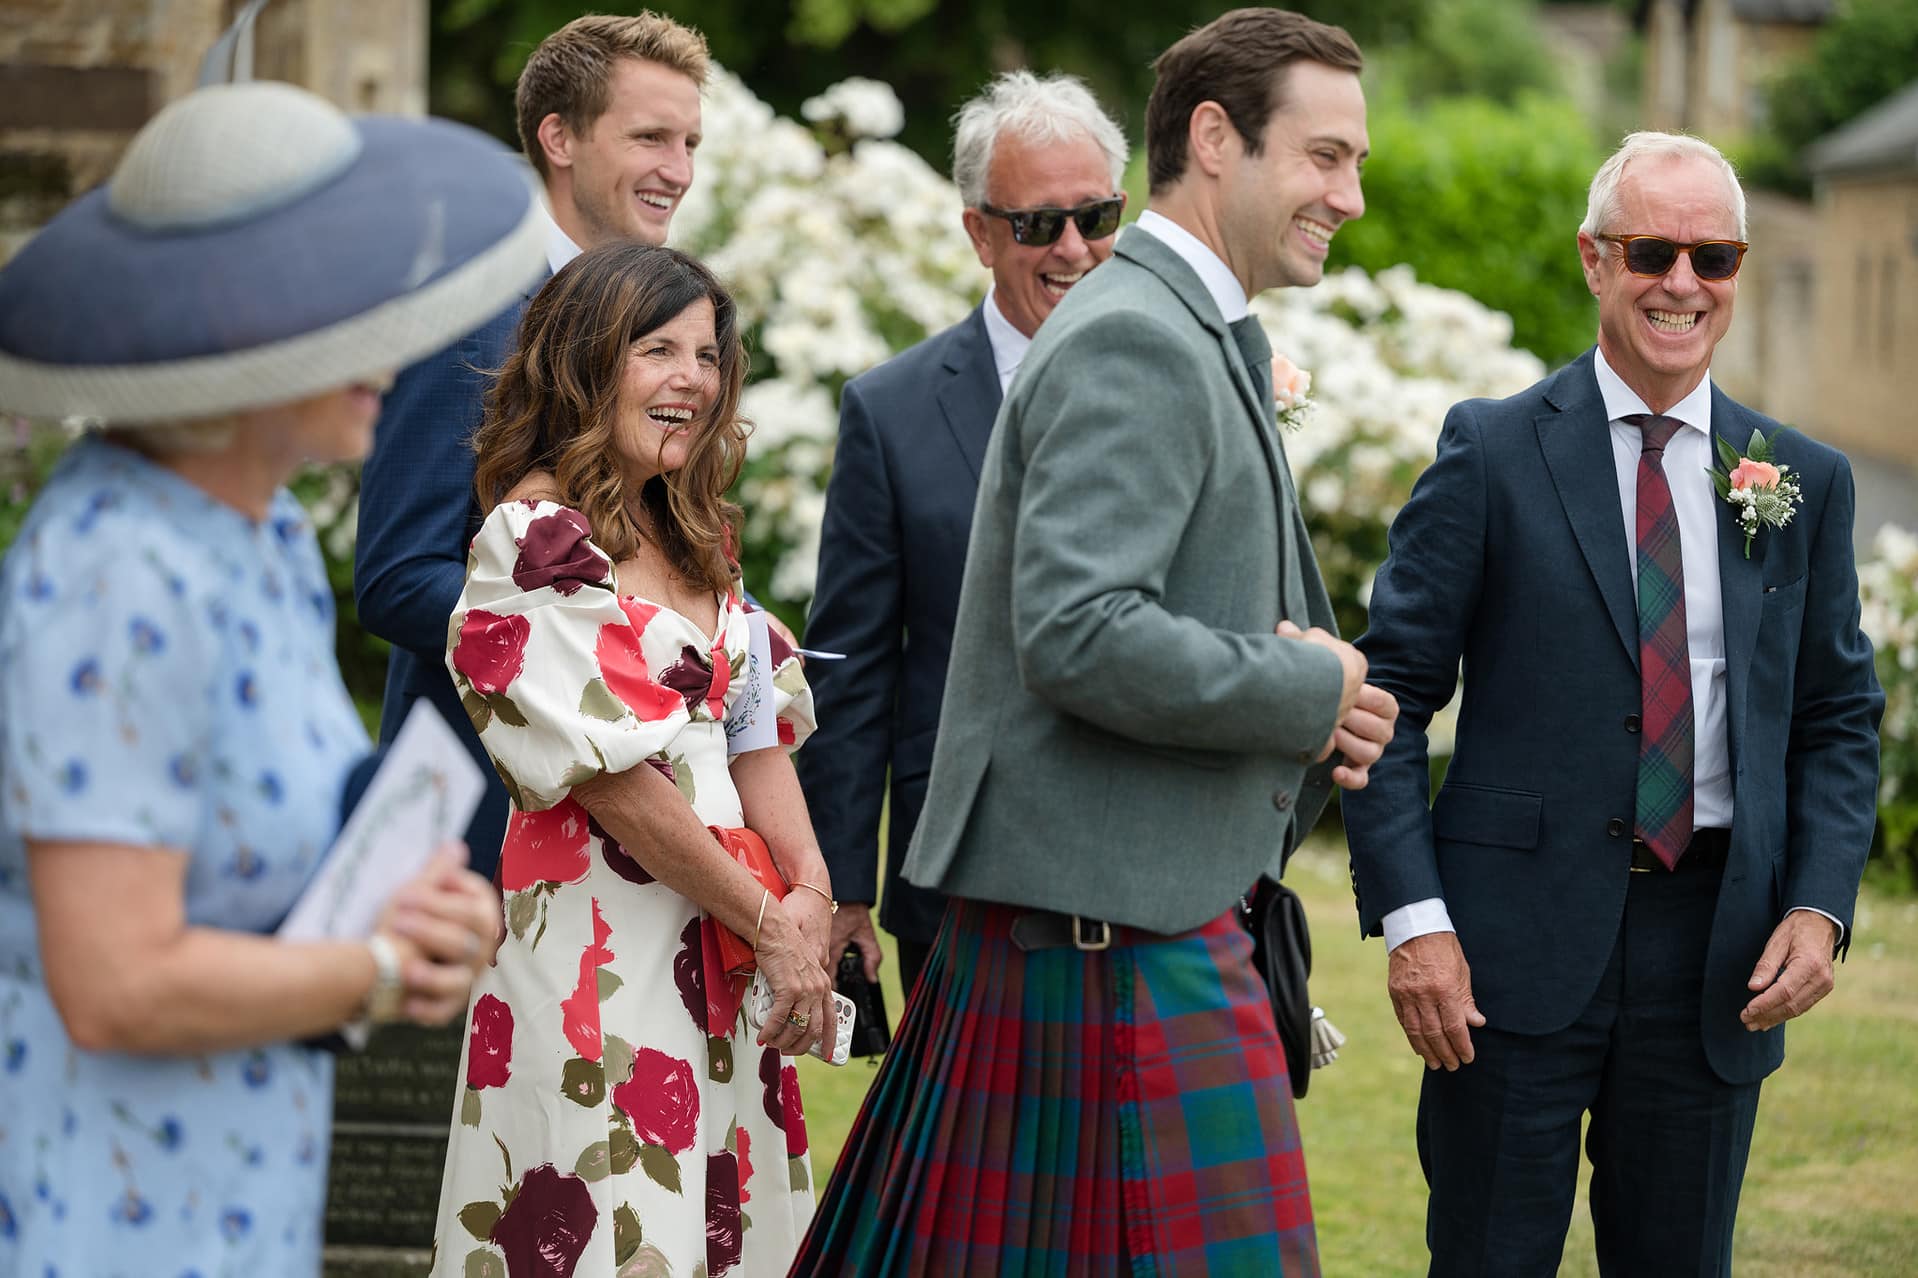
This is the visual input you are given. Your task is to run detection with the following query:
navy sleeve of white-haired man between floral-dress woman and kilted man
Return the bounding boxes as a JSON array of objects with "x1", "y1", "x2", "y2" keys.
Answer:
[{"x1": 796, "y1": 382, "x2": 905, "y2": 904}]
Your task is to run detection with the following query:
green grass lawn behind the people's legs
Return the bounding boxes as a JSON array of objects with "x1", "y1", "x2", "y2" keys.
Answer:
[{"x1": 800, "y1": 846, "x2": 1918, "y2": 1278}]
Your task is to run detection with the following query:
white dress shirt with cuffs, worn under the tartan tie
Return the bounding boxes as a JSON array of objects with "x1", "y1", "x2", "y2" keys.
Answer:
[{"x1": 1379, "y1": 351, "x2": 1843, "y2": 952}]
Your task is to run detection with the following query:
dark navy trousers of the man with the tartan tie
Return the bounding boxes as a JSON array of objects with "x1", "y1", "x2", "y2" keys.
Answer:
[{"x1": 1417, "y1": 862, "x2": 1759, "y2": 1278}]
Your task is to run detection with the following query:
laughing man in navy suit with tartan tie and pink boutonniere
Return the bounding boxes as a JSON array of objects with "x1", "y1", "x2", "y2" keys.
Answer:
[{"x1": 1345, "y1": 134, "x2": 1883, "y2": 1278}]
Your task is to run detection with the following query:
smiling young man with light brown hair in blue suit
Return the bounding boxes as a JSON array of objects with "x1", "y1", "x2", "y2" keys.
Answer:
[{"x1": 353, "y1": 13, "x2": 706, "y2": 873}]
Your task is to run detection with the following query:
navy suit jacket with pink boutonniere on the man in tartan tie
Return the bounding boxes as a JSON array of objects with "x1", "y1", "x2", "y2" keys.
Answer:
[{"x1": 1343, "y1": 353, "x2": 1883, "y2": 1082}]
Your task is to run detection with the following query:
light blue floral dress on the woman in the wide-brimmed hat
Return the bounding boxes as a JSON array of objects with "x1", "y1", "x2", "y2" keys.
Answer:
[{"x1": 0, "y1": 438, "x2": 368, "y2": 1278}]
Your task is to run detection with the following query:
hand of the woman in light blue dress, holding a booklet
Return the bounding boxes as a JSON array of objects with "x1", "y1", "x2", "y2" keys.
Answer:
[{"x1": 380, "y1": 842, "x2": 504, "y2": 1025}]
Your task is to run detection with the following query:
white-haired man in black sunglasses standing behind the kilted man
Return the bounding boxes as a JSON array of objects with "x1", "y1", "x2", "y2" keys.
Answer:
[{"x1": 798, "y1": 71, "x2": 1126, "y2": 992}]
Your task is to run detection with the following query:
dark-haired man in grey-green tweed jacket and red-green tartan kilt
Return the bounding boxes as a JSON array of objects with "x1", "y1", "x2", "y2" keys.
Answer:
[{"x1": 796, "y1": 10, "x2": 1398, "y2": 1276}]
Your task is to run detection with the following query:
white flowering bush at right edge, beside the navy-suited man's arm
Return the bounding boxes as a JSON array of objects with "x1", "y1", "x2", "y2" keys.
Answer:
[{"x1": 1859, "y1": 524, "x2": 1918, "y2": 887}]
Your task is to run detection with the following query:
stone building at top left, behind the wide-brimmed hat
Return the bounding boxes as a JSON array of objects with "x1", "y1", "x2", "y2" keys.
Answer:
[{"x1": 0, "y1": 0, "x2": 426, "y2": 261}]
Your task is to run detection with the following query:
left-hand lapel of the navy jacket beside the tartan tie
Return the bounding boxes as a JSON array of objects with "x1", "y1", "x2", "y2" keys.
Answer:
[{"x1": 1534, "y1": 353, "x2": 1638, "y2": 668}]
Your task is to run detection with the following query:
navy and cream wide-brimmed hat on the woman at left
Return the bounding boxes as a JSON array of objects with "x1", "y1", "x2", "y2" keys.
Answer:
[{"x1": 0, "y1": 81, "x2": 547, "y2": 424}]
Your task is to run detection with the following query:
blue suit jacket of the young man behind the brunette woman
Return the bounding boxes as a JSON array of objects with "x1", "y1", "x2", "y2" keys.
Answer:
[{"x1": 353, "y1": 291, "x2": 529, "y2": 875}]
